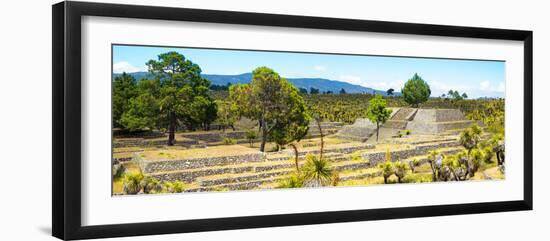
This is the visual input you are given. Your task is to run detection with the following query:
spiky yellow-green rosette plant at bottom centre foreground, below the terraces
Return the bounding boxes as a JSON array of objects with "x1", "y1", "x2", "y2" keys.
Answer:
[{"x1": 302, "y1": 155, "x2": 333, "y2": 187}]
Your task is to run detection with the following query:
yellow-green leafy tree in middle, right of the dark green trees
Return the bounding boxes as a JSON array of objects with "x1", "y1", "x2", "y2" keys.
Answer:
[{"x1": 229, "y1": 67, "x2": 309, "y2": 151}]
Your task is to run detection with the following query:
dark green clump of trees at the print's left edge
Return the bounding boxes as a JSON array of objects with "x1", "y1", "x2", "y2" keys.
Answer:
[{"x1": 118, "y1": 52, "x2": 217, "y2": 145}]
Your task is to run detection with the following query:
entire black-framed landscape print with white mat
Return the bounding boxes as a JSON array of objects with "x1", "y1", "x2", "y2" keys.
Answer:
[{"x1": 53, "y1": 2, "x2": 533, "y2": 239}]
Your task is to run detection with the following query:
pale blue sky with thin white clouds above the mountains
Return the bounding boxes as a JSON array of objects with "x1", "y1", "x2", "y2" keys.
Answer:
[{"x1": 113, "y1": 45, "x2": 505, "y2": 98}]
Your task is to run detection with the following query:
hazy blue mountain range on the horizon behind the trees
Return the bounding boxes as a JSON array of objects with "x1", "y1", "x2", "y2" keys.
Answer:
[{"x1": 113, "y1": 72, "x2": 400, "y2": 95}]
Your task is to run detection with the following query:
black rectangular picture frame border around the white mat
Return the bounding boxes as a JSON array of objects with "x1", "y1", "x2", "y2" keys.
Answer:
[{"x1": 52, "y1": 2, "x2": 533, "y2": 239}]
